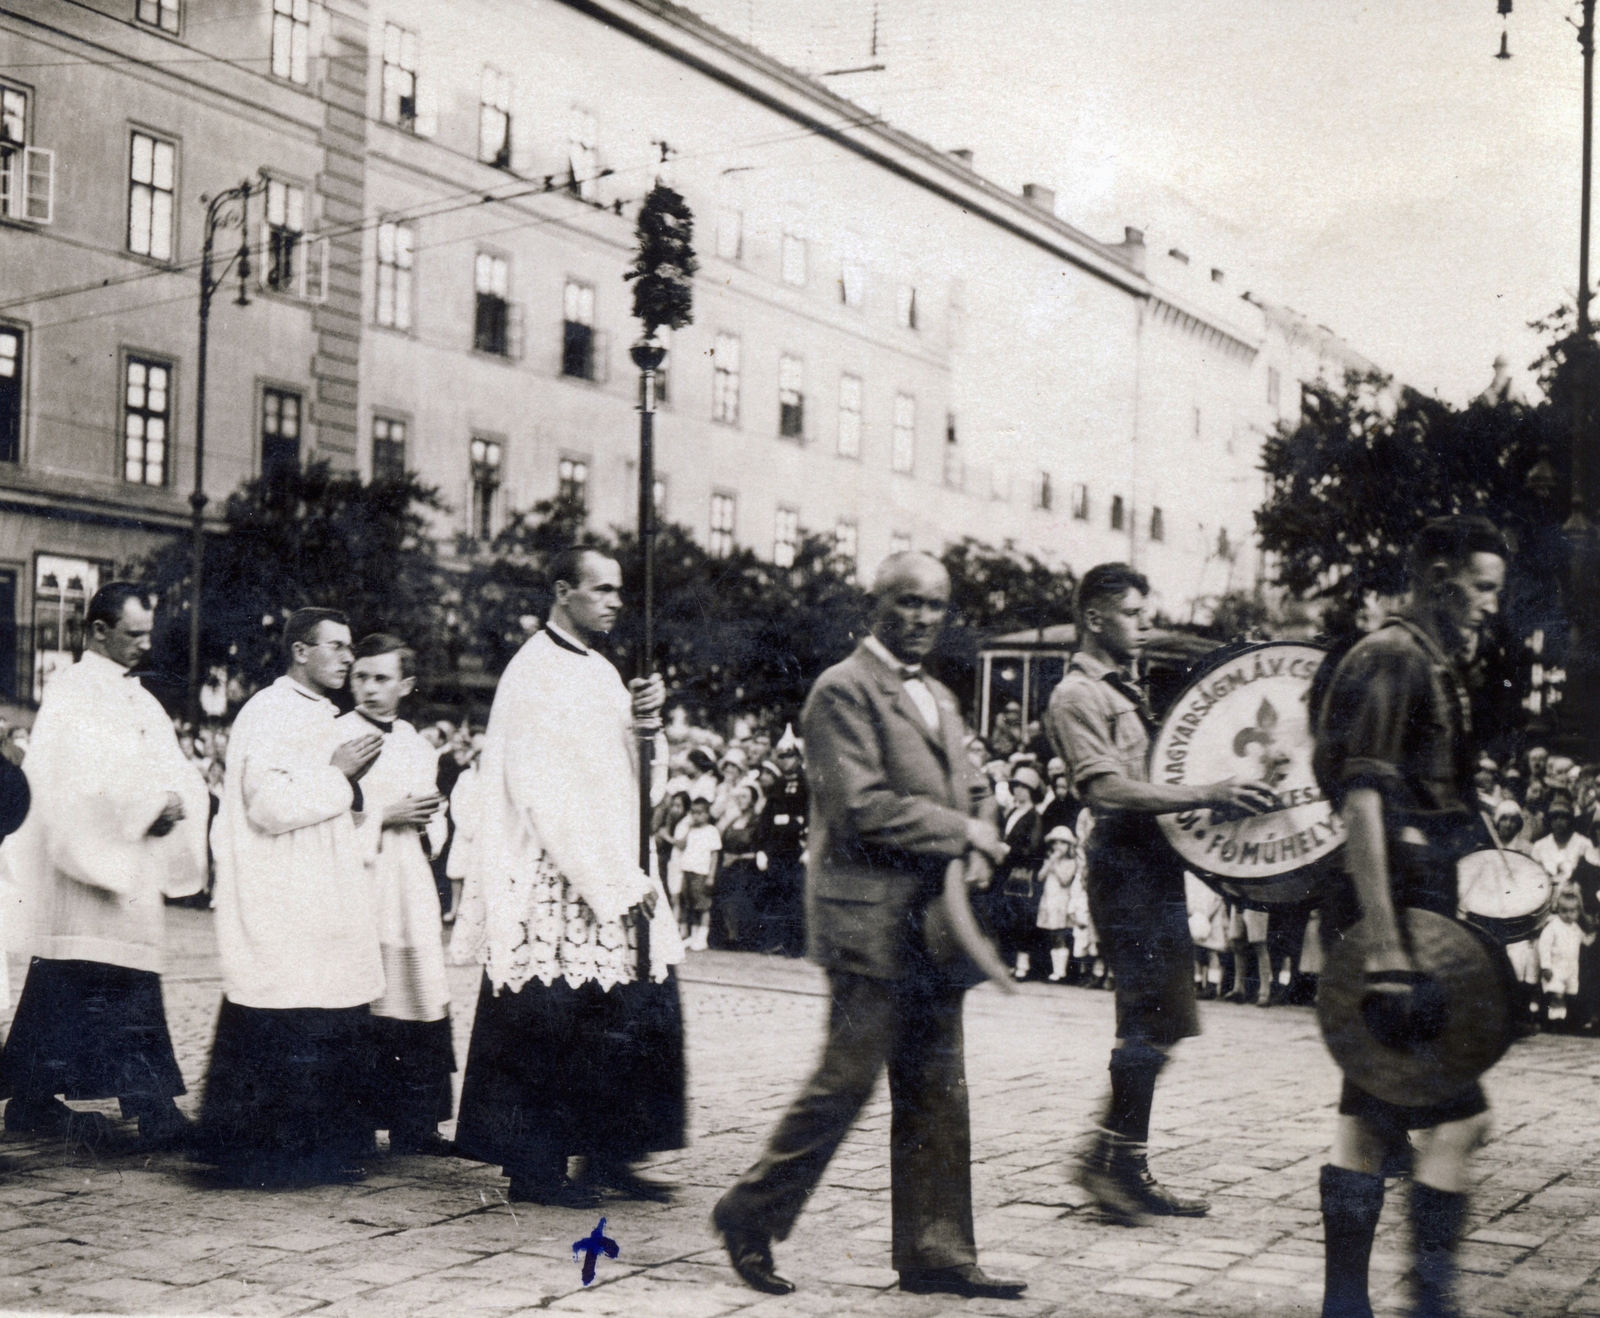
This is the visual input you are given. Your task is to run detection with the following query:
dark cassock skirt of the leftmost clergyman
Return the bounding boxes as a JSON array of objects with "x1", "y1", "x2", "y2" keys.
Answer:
[{"x1": 0, "y1": 957, "x2": 184, "y2": 1099}]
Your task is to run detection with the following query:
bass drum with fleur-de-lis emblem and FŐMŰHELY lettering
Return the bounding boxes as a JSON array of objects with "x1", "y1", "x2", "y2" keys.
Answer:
[{"x1": 1150, "y1": 641, "x2": 1344, "y2": 907}]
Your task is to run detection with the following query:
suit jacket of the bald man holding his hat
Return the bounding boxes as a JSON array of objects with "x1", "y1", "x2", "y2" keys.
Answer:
[{"x1": 800, "y1": 645, "x2": 978, "y2": 979}]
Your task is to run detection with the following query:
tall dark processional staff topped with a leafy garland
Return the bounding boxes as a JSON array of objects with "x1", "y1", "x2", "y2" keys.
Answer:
[{"x1": 624, "y1": 177, "x2": 699, "y2": 872}]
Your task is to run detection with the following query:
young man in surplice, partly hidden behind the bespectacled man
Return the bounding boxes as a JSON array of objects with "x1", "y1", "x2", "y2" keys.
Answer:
[{"x1": 339, "y1": 632, "x2": 456, "y2": 1155}]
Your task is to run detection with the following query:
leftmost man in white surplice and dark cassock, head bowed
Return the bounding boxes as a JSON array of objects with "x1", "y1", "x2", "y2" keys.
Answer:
[{"x1": 0, "y1": 581, "x2": 210, "y2": 1147}]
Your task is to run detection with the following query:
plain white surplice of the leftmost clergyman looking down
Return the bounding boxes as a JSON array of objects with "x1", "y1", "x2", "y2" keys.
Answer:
[{"x1": 0, "y1": 651, "x2": 211, "y2": 974}]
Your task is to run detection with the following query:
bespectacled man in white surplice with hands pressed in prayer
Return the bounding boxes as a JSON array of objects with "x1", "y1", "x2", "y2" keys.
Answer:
[{"x1": 200, "y1": 608, "x2": 384, "y2": 1184}]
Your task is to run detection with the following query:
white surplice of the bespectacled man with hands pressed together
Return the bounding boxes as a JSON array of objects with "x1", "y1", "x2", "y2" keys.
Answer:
[{"x1": 211, "y1": 677, "x2": 384, "y2": 1009}]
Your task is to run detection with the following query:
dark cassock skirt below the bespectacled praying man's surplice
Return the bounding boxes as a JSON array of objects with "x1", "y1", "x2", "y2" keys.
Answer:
[{"x1": 197, "y1": 998, "x2": 374, "y2": 1179}]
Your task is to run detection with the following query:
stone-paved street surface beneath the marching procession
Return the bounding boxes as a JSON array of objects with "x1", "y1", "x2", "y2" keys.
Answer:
[{"x1": 0, "y1": 912, "x2": 1600, "y2": 1318}]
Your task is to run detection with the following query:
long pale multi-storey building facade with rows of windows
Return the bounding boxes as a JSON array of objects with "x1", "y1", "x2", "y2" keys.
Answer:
[{"x1": 0, "y1": 0, "x2": 1376, "y2": 701}]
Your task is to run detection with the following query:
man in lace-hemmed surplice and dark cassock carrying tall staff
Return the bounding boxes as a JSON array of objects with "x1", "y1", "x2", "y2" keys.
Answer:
[{"x1": 451, "y1": 550, "x2": 685, "y2": 1204}]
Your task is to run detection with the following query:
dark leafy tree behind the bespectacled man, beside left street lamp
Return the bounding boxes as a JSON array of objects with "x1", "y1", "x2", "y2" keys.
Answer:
[{"x1": 136, "y1": 462, "x2": 448, "y2": 710}]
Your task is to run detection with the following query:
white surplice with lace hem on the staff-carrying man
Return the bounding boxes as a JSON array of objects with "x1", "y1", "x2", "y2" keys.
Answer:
[{"x1": 450, "y1": 629, "x2": 683, "y2": 992}]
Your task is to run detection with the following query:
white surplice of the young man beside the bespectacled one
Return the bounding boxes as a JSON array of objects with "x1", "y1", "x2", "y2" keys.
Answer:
[{"x1": 338, "y1": 710, "x2": 450, "y2": 1020}]
